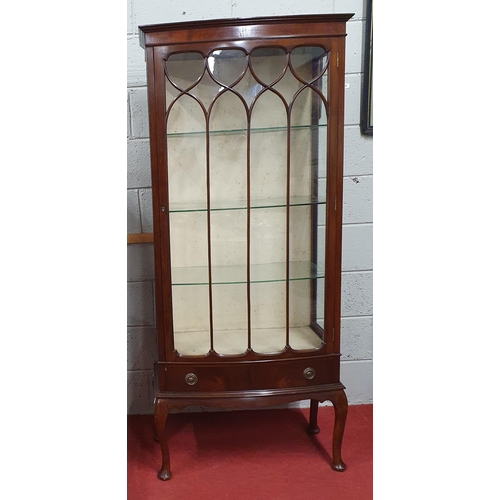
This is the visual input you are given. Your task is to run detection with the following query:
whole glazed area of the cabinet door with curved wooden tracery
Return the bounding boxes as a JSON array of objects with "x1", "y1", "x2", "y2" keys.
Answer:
[{"x1": 164, "y1": 42, "x2": 330, "y2": 356}]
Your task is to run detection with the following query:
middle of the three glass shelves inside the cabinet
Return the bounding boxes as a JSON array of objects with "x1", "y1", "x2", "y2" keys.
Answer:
[{"x1": 169, "y1": 196, "x2": 326, "y2": 213}]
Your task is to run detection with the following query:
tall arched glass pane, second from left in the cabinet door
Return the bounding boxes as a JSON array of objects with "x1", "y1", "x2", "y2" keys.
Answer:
[{"x1": 209, "y1": 86, "x2": 248, "y2": 355}]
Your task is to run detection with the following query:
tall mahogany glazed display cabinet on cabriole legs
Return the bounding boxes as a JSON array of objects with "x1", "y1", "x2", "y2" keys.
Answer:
[{"x1": 139, "y1": 14, "x2": 352, "y2": 480}]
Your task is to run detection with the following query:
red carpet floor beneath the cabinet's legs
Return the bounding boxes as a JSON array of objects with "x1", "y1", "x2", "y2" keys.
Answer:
[{"x1": 128, "y1": 405, "x2": 373, "y2": 500}]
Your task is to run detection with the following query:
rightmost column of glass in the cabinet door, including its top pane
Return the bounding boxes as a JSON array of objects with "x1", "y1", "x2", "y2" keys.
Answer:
[{"x1": 289, "y1": 47, "x2": 327, "y2": 350}]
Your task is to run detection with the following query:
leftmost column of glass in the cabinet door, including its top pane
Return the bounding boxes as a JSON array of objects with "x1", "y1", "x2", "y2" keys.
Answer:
[{"x1": 165, "y1": 53, "x2": 210, "y2": 356}]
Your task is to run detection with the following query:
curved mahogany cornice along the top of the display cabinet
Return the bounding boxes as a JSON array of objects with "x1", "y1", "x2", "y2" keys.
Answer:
[{"x1": 139, "y1": 14, "x2": 354, "y2": 48}]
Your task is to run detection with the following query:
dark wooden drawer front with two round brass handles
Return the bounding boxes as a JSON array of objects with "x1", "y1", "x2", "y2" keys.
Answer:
[{"x1": 158, "y1": 356, "x2": 338, "y2": 392}]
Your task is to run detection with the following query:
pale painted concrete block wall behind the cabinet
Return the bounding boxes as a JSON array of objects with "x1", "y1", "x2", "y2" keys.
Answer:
[{"x1": 127, "y1": 0, "x2": 373, "y2": 414}]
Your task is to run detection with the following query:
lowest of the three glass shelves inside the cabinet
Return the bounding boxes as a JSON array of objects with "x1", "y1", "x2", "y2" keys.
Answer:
[{"x1": 172, "y1": 262, "x2": 324, "y2": 286}]
